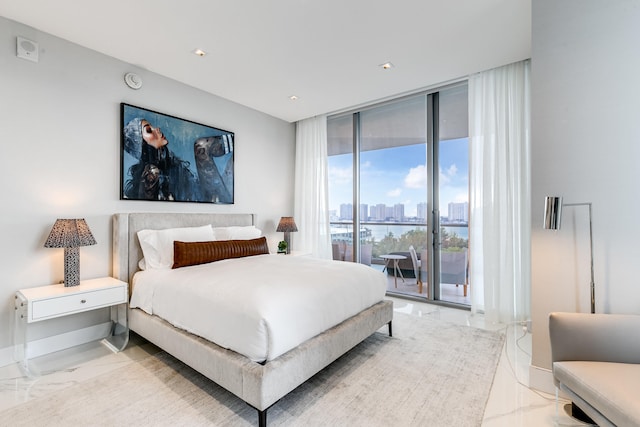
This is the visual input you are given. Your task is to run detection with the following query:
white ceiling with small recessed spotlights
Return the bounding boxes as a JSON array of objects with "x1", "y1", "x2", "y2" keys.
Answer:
[{"x1": 0, "y1": 0, "x2": 531, "y2": 122}]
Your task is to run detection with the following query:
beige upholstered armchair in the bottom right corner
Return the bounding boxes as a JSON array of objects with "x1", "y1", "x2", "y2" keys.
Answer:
[{"x1": 549, "y1": 313, "x2": 640, "y2": 427}]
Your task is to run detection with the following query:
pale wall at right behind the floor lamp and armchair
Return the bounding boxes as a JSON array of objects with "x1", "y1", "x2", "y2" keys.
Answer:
[{"x1": 531, "y1": 0, "x2": 640, "y2": 388}]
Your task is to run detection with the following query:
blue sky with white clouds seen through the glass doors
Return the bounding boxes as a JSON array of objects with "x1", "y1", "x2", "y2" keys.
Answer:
[{"x1": 329, "y1": 138, "x2": 469, "y2": 216}]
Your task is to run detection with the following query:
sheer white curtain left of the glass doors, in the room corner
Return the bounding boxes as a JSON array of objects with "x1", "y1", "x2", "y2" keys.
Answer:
[{"x1": 294, "y1": 116, "x2": 331, "y2": 259}]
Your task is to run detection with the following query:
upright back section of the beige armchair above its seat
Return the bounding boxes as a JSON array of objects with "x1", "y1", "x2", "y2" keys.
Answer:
[{"x1": 549, "y1": 313, "x2": 640, "y2": 364}]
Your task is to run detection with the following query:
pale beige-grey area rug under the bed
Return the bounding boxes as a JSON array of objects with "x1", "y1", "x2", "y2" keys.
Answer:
[{"x1": 0, "y1": 313, "x2": 504, "y2": 427}]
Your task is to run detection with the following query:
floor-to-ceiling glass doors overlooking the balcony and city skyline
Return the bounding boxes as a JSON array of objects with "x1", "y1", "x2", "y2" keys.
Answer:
[{"x1": 327, "y1": 85, "x2": 469, "y2": 304}]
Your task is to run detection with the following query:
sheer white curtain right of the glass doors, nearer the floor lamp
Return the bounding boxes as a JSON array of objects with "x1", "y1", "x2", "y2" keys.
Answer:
[{"x1": 469, "y1": 60, "x2": 531, "y2": 323}]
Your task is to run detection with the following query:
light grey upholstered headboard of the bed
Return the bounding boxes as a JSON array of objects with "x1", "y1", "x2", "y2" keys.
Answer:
[{"x1": 113, "y1": 212, "x2": 256, "y2": 283}]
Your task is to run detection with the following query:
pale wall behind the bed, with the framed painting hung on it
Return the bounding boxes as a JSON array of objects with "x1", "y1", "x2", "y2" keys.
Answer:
[{"x1": 0, "y1": 17, "x2": 295, "y2": 365}]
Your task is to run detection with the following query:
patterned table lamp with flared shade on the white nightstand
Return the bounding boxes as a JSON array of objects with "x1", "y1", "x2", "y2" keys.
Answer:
[{"x1": 44, "y1": 219, "x2": 96, "y2": 286}]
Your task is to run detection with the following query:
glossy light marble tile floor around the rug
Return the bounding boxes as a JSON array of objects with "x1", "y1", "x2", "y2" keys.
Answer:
[{"x1": 0, "y1": 298, "x2": 585, "y2": 427}]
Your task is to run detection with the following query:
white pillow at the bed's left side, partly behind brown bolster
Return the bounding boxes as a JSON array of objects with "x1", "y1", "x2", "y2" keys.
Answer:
[{"x1": 138, "y1": 225, "x2": 214, "y2": 269}]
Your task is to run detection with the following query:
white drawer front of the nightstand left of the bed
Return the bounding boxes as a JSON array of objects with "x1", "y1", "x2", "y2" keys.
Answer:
[{"x1": 29, "y1": 286, "x2": 127, "y2": 322}]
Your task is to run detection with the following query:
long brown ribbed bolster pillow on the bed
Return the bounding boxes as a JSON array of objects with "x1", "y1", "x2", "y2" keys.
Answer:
[{"x1": 172, "y1": 236, "x2": 269, "y2": 268}]
